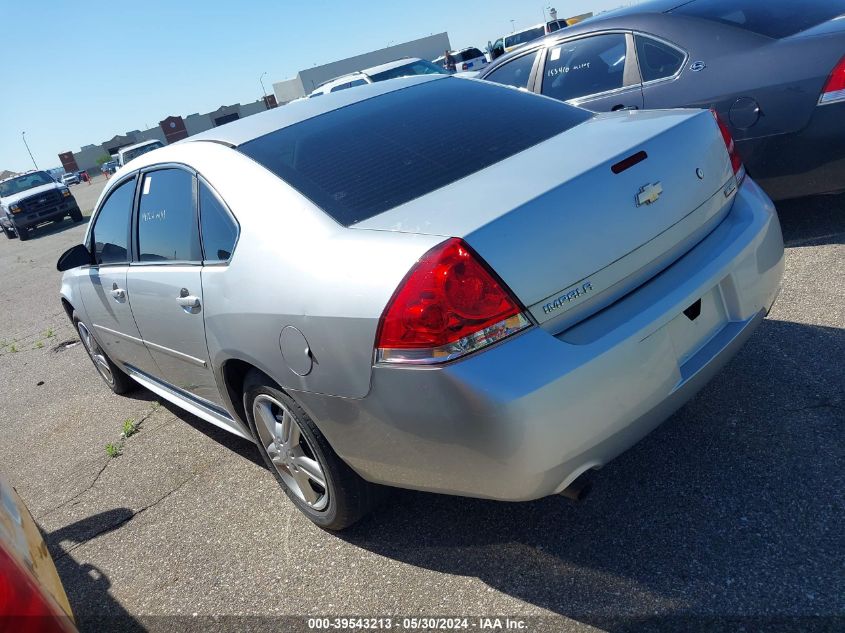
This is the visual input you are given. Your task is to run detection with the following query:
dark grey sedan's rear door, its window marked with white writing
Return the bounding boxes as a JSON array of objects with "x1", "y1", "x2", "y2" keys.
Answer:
[{"x1": 535, "y1": 33, "x2": 643, "y2": 112}]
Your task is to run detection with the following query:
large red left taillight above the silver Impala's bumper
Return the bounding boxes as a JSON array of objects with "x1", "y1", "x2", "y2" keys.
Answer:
[{"x1": 376, "y1": 238, "x2": 528, "y2": 363}]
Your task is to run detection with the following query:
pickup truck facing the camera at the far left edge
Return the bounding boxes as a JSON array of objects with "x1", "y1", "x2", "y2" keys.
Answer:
[{"x1": 0, "y1": 171, "x2": 82, "y2": 241}]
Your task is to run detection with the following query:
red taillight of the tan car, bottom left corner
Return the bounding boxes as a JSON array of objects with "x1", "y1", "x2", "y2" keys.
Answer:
[{"x1": 0, "y1": 546, "x2": 76, "y2": 633}]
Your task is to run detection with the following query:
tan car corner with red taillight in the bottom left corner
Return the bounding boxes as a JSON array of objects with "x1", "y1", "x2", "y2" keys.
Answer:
[{"x1": 0, "y1": 477, "x2": 76, "y2": 633}]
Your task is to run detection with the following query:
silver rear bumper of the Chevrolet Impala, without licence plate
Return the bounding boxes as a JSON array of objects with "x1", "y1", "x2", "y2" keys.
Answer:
[{"x1": 297, "y1": 179, "x2": 783, "y2": 501}]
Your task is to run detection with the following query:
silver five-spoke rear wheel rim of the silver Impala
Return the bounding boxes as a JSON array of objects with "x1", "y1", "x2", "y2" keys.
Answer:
[{"x1": 252, "y1": 394, "x2": 329, "y2": 512}]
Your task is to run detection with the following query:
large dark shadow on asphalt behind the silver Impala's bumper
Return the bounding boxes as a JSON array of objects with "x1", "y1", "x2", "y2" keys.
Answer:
[{"x1": 339, "y1": 320, "x2": 845, "y2": 631}]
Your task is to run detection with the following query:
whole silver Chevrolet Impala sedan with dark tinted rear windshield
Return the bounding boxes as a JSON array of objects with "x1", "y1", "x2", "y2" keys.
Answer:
[{"x1": 59, "y1": 77, "x2": 783, "y2": 529}]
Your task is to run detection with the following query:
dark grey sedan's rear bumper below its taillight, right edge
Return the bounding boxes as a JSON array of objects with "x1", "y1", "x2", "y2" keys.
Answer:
[{"x1": 737, "y1": 102, "x2": 845, "y2": 200}]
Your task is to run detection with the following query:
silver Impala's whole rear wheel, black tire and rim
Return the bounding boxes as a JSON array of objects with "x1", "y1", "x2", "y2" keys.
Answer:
[{"x1": 239, "y1": 371, "x2": 383, "y2": 530}]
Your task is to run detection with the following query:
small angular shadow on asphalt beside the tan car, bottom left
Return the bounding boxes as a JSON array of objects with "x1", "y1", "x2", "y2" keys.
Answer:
[{"x1": 44, "y1": 508, "x2": 146, "y2": 633}]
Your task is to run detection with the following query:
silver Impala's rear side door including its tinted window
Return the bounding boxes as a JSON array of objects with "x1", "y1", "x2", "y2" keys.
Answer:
[{"x1": 127, "y1": 166, "x2": 222, "y2": 405}]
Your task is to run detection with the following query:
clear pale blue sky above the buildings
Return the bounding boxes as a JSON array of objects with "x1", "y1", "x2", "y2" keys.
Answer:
[{"x1": 0, "y1": 0, "x2": 631, "y2": 171}]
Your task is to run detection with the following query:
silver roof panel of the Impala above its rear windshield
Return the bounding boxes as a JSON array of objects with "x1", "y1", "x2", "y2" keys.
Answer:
[{"x1": 186, "y1": 74, "x2": 448, "y2": 147}]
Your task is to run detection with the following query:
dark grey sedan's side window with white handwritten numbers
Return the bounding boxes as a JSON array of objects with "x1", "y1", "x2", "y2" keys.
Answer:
[{"x1": 542, "y1": 33, "x2": 627, "y2": 101}]
